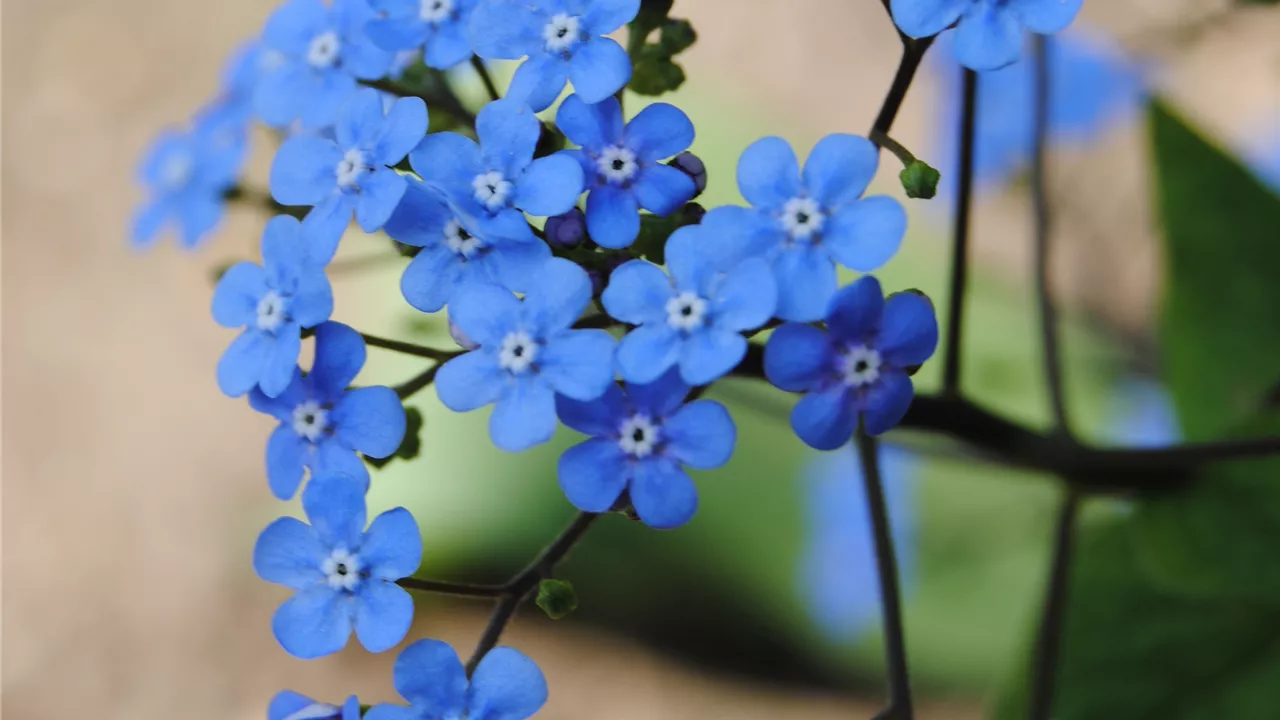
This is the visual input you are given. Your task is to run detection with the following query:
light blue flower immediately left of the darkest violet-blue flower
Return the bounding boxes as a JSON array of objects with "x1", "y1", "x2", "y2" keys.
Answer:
[{"x1": 600, "y1": 225, "x2": 778, "y2": 386}]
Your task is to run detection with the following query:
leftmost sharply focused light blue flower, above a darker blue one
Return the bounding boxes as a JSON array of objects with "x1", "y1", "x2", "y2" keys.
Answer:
[{"x1": 212, "y1": 215, "x2": 333, "y2": 397}]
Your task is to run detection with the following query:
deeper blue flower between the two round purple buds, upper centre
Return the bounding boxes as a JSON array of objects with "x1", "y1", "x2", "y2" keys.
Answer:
[{"x1": 556, "y1": 94, "x2": 698, "y2": 249}]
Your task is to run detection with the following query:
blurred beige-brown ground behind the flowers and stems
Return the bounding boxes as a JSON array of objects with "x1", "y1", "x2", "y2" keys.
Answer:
[{"x1": 0, "y1": 0, "x2": 1280, "y2": 720}]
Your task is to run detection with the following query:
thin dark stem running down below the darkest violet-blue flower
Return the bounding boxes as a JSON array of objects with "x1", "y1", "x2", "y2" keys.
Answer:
[{"x1": 856, "y1": 429, "x2": 913, "y2": 720}]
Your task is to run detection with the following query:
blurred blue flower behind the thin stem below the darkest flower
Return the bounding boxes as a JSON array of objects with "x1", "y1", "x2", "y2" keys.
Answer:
[{"x1": 800, "y1": 445, "x2": 915, "y2": 642}]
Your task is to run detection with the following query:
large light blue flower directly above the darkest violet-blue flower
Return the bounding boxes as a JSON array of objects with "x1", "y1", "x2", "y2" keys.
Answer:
[{"x1": 703, "y1": 135, "x2": 906, "y2": 323}]
